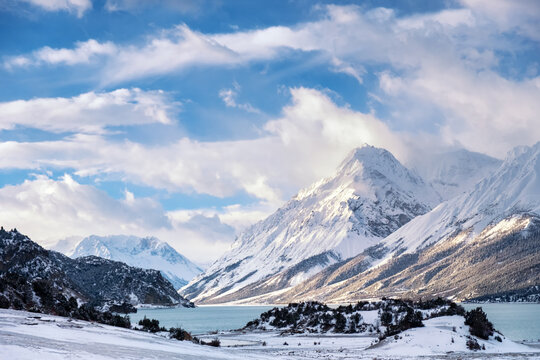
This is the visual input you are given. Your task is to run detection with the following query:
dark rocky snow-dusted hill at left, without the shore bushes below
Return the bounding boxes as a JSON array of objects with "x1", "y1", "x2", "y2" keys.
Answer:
[{"x1": 0, "y1": 228, "x2": 193, "y2": 312}]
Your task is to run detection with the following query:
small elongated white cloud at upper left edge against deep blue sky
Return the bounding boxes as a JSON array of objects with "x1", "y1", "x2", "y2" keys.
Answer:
[{"x1": 4, "y1": 39, "x2": 116, "y2": 70}]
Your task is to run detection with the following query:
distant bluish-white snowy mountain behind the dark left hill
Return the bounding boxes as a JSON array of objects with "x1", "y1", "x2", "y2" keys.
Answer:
[{"x1": 69, "y1": 235, "x2": 202, "y2": 289}]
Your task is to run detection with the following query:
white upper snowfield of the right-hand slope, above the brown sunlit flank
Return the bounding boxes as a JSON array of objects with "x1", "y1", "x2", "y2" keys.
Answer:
[{"x1": 381, "y1": 142, "x2": 540, "y2": 257}]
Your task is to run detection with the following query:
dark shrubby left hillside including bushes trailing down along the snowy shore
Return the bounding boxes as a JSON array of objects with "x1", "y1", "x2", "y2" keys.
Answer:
[{"x1": 0, "y1": 228, "x2": 220, "y2": 346}]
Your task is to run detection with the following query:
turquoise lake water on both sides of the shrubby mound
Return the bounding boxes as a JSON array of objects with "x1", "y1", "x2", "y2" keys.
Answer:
[{"x1": 130, "y1": 303, "x2": 540, "y2": 341}]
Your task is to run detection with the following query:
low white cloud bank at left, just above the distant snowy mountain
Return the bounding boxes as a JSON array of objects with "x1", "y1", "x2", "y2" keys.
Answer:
[{"x1": 0, "y1": 175, "x2": 234, "y2": 262}]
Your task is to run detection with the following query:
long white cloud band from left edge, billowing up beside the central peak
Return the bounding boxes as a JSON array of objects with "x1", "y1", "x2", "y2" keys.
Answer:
[{"x1": 0, "y1": 88, "x2": 406, "y2": 206}]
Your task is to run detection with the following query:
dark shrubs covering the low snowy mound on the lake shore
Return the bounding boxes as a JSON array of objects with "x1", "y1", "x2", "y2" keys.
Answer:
[{"x1": 244, "y1": 298, "x2": 494, "y2": 339}]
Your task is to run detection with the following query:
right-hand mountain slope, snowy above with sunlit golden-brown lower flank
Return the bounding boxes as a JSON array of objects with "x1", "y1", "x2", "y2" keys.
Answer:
[{"x1": 266, "y1": 143, "x2": 540, "y2": 302}]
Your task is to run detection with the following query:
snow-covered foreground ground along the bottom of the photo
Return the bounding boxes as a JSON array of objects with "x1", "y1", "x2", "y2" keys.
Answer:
[{"x1": 0, "y1": 310, "x2": 540, "y2": 360}]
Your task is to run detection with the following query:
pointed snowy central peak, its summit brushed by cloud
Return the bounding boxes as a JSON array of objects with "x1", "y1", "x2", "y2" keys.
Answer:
[{"x1": 181, "y1": 146, "x2": 440, "y2": 303}]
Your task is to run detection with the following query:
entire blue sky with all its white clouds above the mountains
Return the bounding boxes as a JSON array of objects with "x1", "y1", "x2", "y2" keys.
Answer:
[{"x1": 0, "y1": 0, "x2": 540, "y2": 262}]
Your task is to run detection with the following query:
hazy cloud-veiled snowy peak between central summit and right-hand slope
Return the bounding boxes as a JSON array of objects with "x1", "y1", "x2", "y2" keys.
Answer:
[{"x1": 414, "y1": 149, "x2": 502, "y2": 200}]
